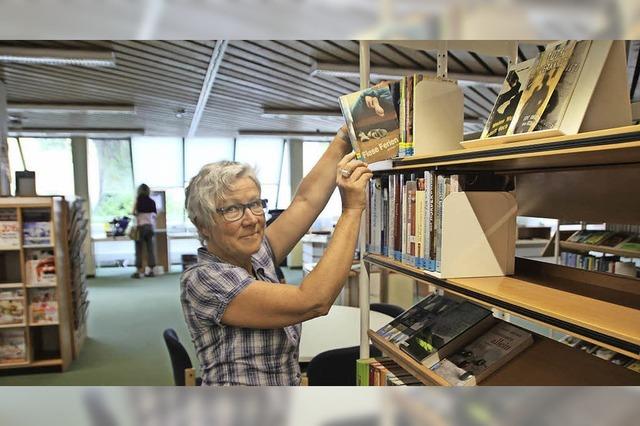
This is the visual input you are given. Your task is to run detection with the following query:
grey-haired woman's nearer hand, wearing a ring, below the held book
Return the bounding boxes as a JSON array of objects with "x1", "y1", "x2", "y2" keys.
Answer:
[{"x1": 336, "y1": 152, "x2": 373, "y2": 211}]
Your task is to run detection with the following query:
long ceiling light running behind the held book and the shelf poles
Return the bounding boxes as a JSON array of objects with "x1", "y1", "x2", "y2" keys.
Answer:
[{"x1": 311, "y1": 62, "x2": 504, "y2": 88}]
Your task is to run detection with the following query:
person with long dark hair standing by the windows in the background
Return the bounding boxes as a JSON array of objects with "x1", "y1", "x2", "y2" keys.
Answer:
[{"x1": 131, "y1": 183, "x2": 158, "y2": 278}]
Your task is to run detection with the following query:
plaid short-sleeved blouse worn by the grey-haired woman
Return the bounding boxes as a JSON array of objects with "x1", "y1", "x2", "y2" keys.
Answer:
[{"x1": 180, "y1": 237, "x2": 301, "y2": 386}]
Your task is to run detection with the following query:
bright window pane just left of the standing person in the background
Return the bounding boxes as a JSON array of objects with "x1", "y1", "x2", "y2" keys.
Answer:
[{"x1": 87, "y1": 139, "x2": 135, "y2": 234}]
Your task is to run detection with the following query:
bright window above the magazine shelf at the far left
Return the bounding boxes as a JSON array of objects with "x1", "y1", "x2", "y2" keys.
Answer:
[{"x1": 8, "y1": 138, "x2": 75, "y2": 198}]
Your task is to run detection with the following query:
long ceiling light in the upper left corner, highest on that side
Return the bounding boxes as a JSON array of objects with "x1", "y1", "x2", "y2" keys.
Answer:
[{"x1": 0, "y1": 47, "x2": 116, "y2": 67}]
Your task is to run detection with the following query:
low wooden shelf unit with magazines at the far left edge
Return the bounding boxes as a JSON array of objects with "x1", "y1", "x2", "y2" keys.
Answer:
[{"x1": 0, "y1": 197, "x2": 73, "y2": 371}]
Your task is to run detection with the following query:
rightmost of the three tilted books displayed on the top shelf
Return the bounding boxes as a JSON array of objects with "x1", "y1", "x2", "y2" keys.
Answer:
[{"x1": 535, "y1": 40, "x2": 591, "y2": 131}]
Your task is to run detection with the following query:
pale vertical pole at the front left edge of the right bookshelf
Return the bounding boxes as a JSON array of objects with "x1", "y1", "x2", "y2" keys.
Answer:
[{"x1": 354, "y1": 40, "x2": 370, "y2": 362}]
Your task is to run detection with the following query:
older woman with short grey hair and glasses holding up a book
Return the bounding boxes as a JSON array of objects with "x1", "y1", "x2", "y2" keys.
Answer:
[{"x1": 181, "y1": 128, "x2": 372, "y2": 385}]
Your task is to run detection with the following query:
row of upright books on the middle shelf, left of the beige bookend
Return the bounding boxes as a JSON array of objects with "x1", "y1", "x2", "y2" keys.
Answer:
[{"x1": 365, "y1": 171, "x2": 512, "y2": 272}]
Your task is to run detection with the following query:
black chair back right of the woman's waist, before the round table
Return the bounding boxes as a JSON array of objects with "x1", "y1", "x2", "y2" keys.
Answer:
[{"x1": 307, "y1": 345, "x2": 382, "y2": 386}]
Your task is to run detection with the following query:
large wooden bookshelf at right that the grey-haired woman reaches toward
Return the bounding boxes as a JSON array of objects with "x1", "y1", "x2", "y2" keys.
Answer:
[{"x1": 360, "y1": 40, "x2": 640, "y2": 385}]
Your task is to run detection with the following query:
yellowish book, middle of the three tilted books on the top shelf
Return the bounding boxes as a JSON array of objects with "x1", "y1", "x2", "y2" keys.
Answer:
[{"x1": 507, "y1": 40, "x2": 576, "y2": 135}]
